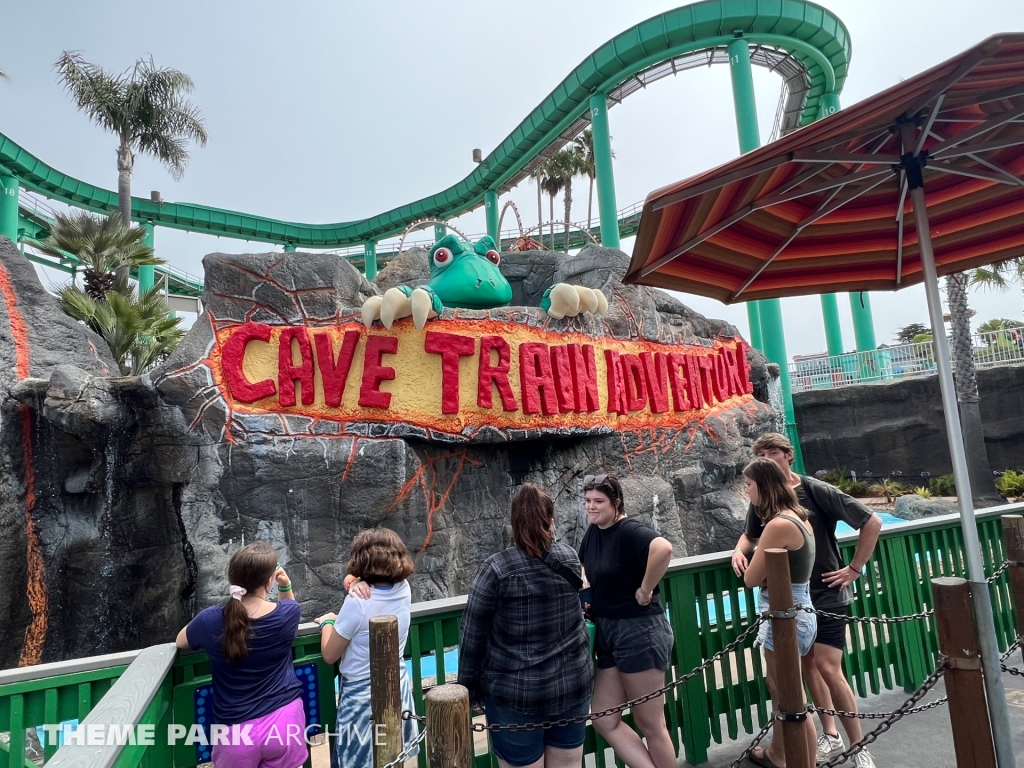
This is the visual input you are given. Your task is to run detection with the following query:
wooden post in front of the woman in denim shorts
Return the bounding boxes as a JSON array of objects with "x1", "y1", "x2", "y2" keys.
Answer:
[{"x1": 765, "y1": 549, "x2": 814, "y2": 768}]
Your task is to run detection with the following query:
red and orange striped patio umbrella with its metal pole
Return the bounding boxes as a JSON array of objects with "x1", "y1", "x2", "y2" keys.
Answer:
[{"x1": 625, "y1": 34, "x2": 1024, "y2": 766}]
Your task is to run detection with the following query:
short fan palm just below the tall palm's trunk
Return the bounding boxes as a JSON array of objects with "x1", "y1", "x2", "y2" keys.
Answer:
[{"x1": 28, "y1": 211, "x2": 158, "y2": 301}]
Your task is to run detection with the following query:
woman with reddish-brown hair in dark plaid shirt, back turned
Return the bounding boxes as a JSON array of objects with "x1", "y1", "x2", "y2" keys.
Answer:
[{"x1": 459, "y1": 483, "x2": 594, "y2": 768}]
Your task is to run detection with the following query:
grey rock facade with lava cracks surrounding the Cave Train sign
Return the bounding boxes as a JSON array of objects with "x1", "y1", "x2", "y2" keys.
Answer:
[{"x1": 0, "y1": 241, "x2": 773, "y2": 667}]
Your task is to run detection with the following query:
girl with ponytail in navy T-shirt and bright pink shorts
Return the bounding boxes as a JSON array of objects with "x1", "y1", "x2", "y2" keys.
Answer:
[{"x1": 176, "y1": 542, "x2": 309, "y2": 768}]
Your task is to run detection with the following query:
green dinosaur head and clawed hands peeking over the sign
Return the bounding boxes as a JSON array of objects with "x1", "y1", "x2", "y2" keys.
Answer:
[{"x1": 362, "y1": 234, "x2": 608, "y2": 329}]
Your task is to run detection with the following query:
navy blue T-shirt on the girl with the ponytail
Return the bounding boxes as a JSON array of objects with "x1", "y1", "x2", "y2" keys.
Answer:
[{"x1": 185, "y1": 600, "x2": 302, "y2": 725}]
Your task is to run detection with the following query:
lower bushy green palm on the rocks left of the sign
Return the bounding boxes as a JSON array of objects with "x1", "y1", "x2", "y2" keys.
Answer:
[{"x1": 57, "y1": 286, "x2": 185, "y2": 376}]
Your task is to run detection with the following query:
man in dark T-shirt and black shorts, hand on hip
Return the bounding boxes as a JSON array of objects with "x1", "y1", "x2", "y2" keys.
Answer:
[{"x1": 732, "y1": 432, "x2": 882, "y2": 768}]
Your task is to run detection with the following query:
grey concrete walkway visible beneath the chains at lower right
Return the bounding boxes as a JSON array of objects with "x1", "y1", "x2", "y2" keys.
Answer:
[{"x1": 680, "y1": 663, "x2": 1024, "y2": 768}]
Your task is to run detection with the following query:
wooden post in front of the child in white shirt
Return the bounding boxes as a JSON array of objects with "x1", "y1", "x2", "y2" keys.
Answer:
[{"x1": 370, "y1": 615, "x2": 404, "y2": 768}]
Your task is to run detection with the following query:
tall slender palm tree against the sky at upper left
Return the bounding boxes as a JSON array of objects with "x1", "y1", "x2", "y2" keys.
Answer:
[{"x1": 54, "y1": 51, "x2": 207, "y2": 227}]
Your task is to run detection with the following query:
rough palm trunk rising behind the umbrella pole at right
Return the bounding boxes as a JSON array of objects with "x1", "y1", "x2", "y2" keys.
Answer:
[{"x1": 946, "y1": 272, "x2": 997, "y2": 506}]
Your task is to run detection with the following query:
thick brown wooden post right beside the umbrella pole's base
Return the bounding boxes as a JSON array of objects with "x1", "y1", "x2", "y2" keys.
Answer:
[{"x1": 932, "y1": 578, "x2": 995, "y2": 768}]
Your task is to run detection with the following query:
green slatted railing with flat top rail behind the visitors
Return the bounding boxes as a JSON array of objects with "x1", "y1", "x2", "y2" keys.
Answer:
[{"x1": 0, "y1": 504, "x2": 1024, "y2": 768}]
